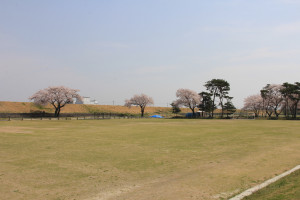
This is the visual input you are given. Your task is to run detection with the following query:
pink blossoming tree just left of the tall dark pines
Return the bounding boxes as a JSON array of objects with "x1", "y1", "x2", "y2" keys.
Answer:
[{"x1": 173, "y1": 88, "x2": 201, "y2": 116}]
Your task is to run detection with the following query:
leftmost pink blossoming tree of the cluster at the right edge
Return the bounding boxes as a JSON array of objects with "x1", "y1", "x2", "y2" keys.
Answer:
[{"x1": 243, "y1": 94, "x2": 263, "y2": 117}]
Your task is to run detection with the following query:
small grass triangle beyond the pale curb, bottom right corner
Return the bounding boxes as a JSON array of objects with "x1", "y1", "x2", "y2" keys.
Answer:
[{"x1": 245, "y1": 170, "x2": 300, "y2": 200}]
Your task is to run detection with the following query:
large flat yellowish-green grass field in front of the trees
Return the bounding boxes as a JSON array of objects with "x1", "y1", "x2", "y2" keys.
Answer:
[{"x1": 0, "y1": 119, "x2": 300, "y2": 200}]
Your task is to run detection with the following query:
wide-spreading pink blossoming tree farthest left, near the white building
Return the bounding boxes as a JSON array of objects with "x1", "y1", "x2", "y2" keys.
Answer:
[{"x1": 29, "y1": 86, "x2": 81, "y2": 117}]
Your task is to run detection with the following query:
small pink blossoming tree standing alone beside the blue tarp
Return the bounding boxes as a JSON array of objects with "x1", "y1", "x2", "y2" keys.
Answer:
[{"x1": 125, "y1": 94, "x2": 154, "y2": 117}]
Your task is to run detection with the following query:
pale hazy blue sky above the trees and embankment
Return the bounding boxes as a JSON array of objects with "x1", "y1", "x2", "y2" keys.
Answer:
[{"x1": 0, "y1": 0, "x2": 300, "y2": 107}]
